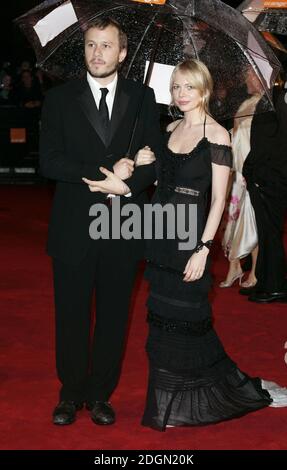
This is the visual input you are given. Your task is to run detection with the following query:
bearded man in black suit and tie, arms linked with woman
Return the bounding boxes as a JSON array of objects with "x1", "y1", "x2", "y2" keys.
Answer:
[{"x1": 40, "y1": 18, "x2": 160, "y2": 425}]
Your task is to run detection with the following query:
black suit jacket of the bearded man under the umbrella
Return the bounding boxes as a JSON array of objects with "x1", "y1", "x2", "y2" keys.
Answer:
[{"x1": 40, "y1": 76, "x2": 160, "y2": 265}]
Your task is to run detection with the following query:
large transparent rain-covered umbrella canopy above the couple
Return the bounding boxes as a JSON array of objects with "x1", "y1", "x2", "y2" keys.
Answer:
[{"x1": 16, "y1": 0, "x2": 280, "y2": 119}]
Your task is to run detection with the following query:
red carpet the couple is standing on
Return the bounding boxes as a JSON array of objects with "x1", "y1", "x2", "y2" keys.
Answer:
[{"x1": 0, "y1": 186, "x2": 287, "y2": 450}]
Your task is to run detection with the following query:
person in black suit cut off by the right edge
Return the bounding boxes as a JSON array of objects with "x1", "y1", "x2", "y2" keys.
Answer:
[{"x1": 241, "y1": 91, "x2": 287, "y2": 303}]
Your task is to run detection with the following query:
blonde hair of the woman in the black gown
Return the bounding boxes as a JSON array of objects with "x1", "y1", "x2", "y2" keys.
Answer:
[{"x1": 169, "y1": 59, "x2": 213, "y2": 114}]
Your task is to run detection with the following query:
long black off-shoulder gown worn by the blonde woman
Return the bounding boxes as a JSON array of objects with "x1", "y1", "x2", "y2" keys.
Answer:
[{"x1": 142, "y1": 122, "x2": 272, "y2": 431}]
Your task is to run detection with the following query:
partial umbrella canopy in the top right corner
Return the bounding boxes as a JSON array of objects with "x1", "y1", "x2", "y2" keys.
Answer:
[{"x1": 238, "y1": 0, "x2": 287, "y2": 35}]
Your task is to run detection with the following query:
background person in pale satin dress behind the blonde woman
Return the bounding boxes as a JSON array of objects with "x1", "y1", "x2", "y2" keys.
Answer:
[{"x1": 219, "y1": 68, "x2": 262, "y2": 289}]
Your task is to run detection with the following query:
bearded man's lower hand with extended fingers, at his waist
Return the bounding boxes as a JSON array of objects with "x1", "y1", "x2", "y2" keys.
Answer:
[{"x1": 82, "y1": 166, "x2": 130, "y2": 196}]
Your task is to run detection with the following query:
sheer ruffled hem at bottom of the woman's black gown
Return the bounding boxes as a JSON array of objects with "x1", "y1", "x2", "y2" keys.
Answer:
[{"x1": 142, "y1": 367, "x2": 272, "y2": 431}]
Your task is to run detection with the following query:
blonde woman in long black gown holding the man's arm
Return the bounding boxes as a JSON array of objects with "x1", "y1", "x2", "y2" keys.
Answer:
[{"x1": 137, "y1": 60, "x2": 278, "y2": 431}]
